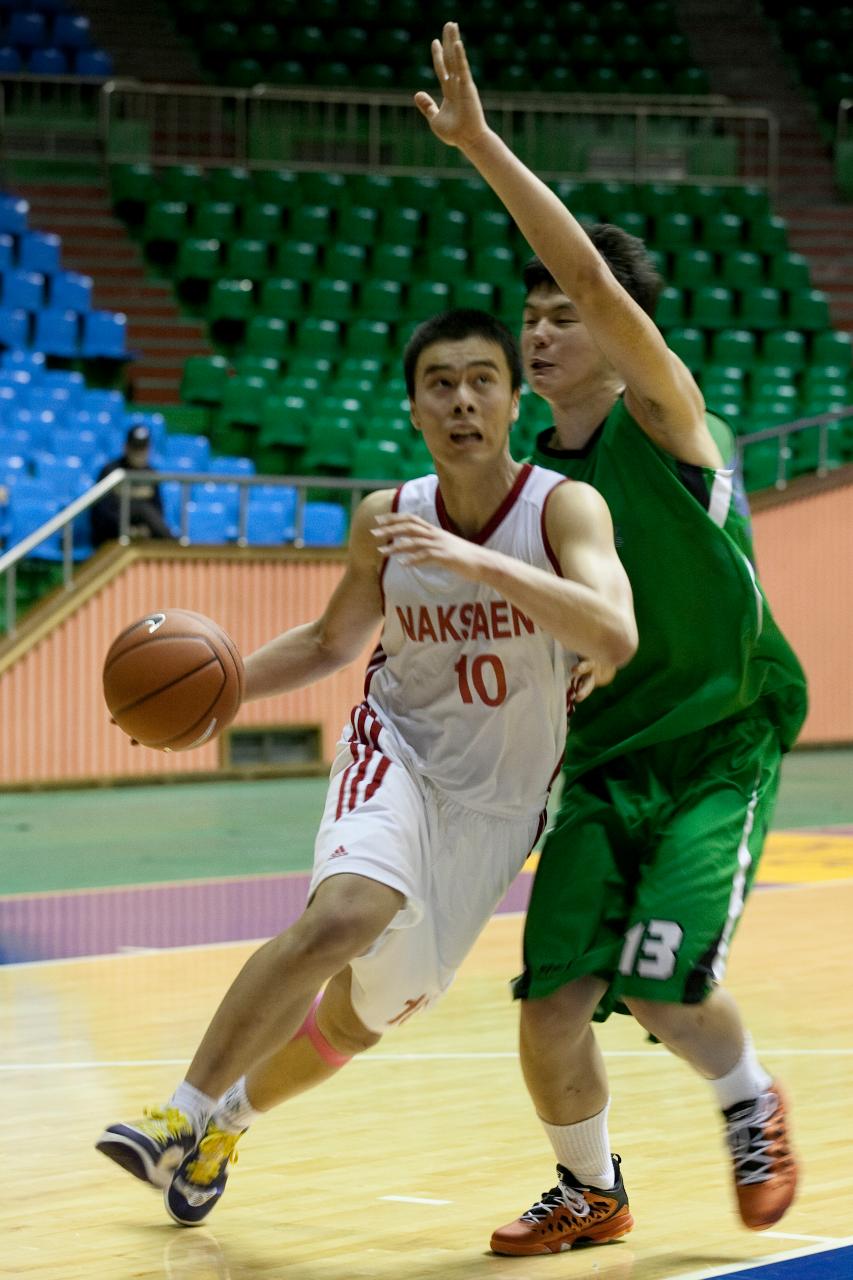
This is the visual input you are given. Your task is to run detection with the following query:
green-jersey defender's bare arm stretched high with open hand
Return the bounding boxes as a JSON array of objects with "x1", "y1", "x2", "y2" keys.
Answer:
[{"x1": 415, "y1": 22, "x2": 722, "y2": 467}]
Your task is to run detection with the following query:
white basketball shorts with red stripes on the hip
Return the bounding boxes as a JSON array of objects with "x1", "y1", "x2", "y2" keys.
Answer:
[{"x1": 310, "y1": 727, "x2": 540, "y2": 1033}]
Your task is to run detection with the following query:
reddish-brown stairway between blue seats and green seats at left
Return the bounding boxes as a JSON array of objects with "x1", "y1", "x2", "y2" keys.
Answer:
[{"x1": 14, "y1": 182, "x2": 211, "y2": 404}]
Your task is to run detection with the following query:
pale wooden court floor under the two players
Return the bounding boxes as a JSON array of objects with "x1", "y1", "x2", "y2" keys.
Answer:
[{"x1": 0, "y1": 879, "x2": 853, "y2": 1280}]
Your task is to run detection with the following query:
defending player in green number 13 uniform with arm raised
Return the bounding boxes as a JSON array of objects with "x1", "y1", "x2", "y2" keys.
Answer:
[{"x1": 415, "y1": 23, "x2": 806, "y2": 1254}]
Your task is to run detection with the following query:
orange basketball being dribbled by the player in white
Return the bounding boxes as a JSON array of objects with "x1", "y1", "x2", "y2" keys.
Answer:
[{"x1": 104, "y1": 609, "x2": 243, "y2": 751}]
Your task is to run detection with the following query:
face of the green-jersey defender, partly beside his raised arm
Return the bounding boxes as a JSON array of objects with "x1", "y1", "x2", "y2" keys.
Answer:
[{"x1": 521, "y1": 285, "x2": 610, "y2": 401}]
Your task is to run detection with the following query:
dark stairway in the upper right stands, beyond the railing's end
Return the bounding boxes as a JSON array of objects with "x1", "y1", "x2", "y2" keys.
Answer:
[{"x1": 675, "y1": 0, "x2": 853, "y2": 332}]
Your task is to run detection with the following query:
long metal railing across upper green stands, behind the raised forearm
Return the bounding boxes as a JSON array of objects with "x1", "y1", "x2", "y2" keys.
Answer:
[{"x1": 100, "y1": 79, "x2": 779, "y2": 188}]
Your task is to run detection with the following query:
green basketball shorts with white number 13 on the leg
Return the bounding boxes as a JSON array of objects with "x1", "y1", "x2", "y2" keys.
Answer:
[{"x1": 514, "y1": 718, "x2": 781, "y2": 1021}]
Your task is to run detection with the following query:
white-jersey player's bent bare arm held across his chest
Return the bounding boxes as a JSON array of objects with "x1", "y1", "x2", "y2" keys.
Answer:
[{"x1": 373, "y1": 484, "x2": 637, "y2": 667}]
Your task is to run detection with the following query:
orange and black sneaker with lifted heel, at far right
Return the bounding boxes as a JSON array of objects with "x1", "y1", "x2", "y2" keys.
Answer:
[{"x1": 724, "y1": 1080, "x2": 797, "y2": 1231}]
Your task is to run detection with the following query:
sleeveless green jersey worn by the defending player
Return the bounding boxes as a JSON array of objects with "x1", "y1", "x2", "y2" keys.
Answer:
[{"x1": 532, "y1": 399, "x2": 807, "y2": 777}]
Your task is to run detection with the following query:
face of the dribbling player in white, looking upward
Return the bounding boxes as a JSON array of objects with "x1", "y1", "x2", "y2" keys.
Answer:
[{"x1": 411, "y1": 334, "x2": 519, "y2": 463}]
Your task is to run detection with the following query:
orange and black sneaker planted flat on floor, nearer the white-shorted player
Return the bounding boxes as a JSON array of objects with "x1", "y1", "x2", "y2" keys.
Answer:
[{"x1": 491, "y1": 1156, "x2": 634, "y2": 1257}]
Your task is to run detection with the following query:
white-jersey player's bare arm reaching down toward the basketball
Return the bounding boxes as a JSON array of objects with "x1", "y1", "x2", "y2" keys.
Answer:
[{"x1": 245, "y1": 489, "x2": 393, "y2": 700}]
